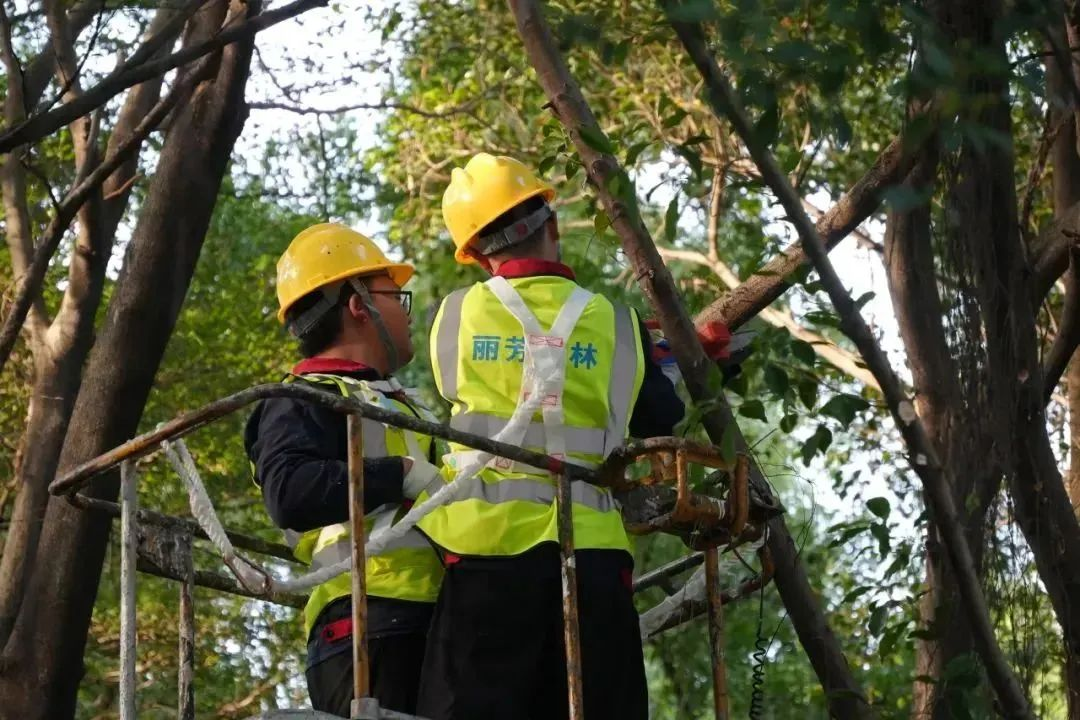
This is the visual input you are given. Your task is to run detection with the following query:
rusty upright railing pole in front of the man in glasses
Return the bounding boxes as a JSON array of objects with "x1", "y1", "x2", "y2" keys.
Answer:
[{"x1": 348, "y1": 413, "x2": 370, "y2": 718}]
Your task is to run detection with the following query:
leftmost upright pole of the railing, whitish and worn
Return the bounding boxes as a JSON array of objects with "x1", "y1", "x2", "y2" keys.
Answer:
[{"x1": 120, "y1": 461, "x2": 138, "y2": 720}]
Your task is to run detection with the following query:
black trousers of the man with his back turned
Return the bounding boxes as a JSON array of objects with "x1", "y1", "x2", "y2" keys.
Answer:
[{"x1": 417, "y1": 544, "x2": 648, "y2": 720}]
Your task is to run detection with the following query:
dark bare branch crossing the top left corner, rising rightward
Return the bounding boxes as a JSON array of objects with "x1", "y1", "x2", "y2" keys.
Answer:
[{"x1": 0, "y1": 0, "x2": 329, "y2": 152}]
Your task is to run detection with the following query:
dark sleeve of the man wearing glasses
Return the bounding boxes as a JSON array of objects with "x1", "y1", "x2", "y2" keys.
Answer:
[{"x1": 244, "y1": 398, "x2": 404, "y2": 532}]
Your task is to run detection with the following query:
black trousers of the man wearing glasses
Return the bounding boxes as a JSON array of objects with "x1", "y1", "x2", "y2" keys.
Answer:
[{"x1": 306, "y1": 634, "x2": 427, "y2": 718}]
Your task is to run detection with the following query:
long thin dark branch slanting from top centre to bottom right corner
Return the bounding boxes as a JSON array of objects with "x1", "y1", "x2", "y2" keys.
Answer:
[{"x1": 659, "y1": 0, "x2": 1035, "y2": 720}]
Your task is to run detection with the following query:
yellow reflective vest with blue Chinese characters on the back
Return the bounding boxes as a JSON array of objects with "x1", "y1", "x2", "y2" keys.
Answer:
[{"x1": 418, "y1": 276, "x2": 645, "y2": 556}]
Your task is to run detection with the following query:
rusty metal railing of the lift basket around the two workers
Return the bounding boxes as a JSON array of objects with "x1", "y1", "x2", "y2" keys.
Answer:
[{"x1": 49, "y1": 384, "x2": 777, "y2": 720}]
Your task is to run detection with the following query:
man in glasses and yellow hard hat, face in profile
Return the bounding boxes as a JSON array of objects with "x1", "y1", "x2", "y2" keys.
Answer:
[{"x1": 244, "y1": 223, "x2": 443, "y2": 717}]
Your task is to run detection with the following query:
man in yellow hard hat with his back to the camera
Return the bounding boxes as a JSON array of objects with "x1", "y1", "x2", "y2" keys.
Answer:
[{"x1": 418, "y1": 153, "x2": 684, "y2": 720}]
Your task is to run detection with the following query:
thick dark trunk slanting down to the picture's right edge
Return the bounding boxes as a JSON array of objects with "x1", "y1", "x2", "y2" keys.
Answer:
[{"x1": 942, "y1": 0, "x2": 1080, "y2": 716}]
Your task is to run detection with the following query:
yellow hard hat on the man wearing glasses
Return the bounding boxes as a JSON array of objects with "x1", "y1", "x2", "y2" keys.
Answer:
[{"x1": 278, "y1": 222, "x2": 414, "y2": 323}]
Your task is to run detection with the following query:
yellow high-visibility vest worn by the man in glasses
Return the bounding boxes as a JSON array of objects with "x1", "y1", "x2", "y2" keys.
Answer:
[{"x1": 285, "y1": 373, "x2": 443, "y2": 635}]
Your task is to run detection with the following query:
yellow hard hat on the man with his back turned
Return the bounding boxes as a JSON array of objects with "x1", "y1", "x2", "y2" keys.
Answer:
[{"x1": 443, "y1": 152, "x2": 555, "y2": 264}]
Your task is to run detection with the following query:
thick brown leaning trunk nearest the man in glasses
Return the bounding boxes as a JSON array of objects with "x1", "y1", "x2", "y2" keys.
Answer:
[{"x1": 0, "y1": 0, "x2": 258, "y2": 720}]
